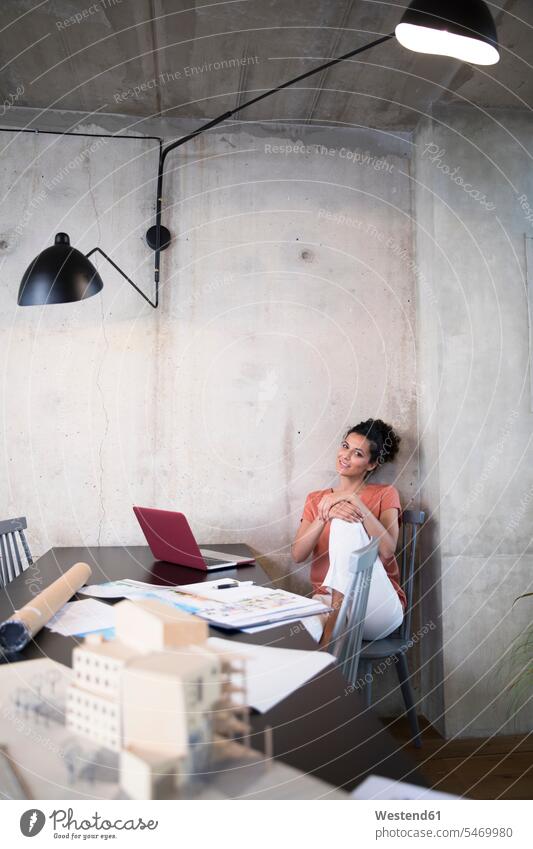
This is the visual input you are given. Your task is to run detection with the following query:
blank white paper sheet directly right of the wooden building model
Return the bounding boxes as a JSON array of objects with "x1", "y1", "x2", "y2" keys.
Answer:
[{"x1": 207, "y1": 637, "x2": 335, "y2": 713}]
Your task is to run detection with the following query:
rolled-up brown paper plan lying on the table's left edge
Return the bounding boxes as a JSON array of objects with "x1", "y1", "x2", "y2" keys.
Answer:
[{"x1": 0, "y1": 563, "x2": 91, "y2": 653}]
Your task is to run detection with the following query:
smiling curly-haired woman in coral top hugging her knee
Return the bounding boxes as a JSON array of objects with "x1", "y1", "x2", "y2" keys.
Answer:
[{"x1": 291, "y1": 419, "x2": 407, "y2": 644}]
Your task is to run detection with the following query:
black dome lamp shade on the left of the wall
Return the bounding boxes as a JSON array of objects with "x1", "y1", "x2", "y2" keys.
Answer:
[{"x1": 17, "y1": 233, "x2": 104, "y2": 307}]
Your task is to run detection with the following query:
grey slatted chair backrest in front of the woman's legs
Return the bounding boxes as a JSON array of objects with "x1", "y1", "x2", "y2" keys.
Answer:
[{"x1": 330, "y1": 538, "x2": 379, "y2": 682}]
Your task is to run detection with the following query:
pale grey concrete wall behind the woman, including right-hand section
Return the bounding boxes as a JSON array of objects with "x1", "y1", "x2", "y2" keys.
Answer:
[{"x1": 4, "y1": 108, "x2": 533, "y2": 736}]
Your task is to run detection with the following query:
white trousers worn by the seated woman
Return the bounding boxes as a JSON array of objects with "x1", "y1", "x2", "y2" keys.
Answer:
[{"x1": 303, "y1": 519, "x2": 403, "y2": 640}]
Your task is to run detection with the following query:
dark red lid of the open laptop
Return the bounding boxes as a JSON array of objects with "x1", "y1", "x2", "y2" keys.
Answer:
[{"x1": 133, "y1": 507, "x2": 207, "y2": 572}]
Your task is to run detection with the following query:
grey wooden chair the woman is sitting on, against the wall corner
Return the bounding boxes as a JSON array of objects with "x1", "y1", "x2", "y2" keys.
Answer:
[{"x1": 360, "y1": 510, "x2": 426, "y2": 749}]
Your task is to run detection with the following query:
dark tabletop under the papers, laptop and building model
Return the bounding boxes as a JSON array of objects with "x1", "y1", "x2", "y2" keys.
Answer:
[{"x1": 0, "y1": 544, "x2": 427, "y2": 790}]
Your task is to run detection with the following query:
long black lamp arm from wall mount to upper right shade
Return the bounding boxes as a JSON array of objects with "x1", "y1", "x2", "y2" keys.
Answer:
[{"x1": 152, "y1": 32, "x2": 395, "y2": 284}]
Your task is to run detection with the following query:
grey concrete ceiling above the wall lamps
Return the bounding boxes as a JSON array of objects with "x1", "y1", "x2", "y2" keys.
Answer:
[{"x1": 0, "y1": 0, "x2": 533, "y2": 130}]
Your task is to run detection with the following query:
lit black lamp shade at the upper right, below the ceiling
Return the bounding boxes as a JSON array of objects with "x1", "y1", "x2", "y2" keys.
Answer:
[{"x1": 396, "y1": 0, "x2": 500, "y2": 65}]
